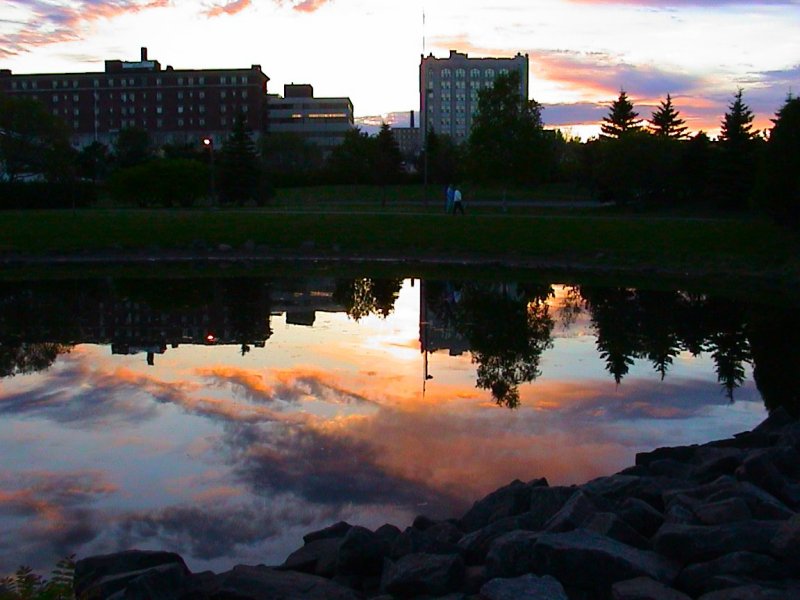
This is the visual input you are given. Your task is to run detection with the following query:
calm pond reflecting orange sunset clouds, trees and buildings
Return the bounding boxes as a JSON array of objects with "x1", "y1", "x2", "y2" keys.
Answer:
[{"x1": 0, "y1": 278, "x2": 800, "y2": 574}]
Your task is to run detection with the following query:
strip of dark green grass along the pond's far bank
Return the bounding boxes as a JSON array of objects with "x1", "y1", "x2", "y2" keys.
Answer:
[{"x1": 0, "y1": 209, "x2": 797, "y2": 272}]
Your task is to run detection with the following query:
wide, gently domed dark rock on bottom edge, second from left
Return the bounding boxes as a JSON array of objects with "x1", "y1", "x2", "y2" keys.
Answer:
[{"x1": 205, "y1": 565, "x2": 359, "y2": 600}]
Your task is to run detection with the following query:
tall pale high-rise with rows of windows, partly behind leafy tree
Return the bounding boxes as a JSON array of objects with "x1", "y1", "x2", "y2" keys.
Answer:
[{"x1": 419, "y1": 50, "x2": 528, "y2": 143}]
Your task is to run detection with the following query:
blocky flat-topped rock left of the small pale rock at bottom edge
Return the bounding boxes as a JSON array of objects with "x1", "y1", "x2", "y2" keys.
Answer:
[{"x1": 381, "y1": 554, "x2": 464, "y2": 597}]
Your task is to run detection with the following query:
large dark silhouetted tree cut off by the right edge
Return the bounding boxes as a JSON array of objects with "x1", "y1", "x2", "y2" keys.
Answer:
[{"x1": 757, "y1": 97, "x2": 800, "y2": 227}]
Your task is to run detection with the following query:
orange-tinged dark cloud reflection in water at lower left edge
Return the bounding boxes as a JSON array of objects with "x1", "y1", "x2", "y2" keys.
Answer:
[{"x1": 0, "y1": 471, "x2": 117, "y2": 574}]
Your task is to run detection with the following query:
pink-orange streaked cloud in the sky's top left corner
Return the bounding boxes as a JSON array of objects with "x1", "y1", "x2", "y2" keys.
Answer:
[{"x1": 0, "y1": 0, "x2": 170, "y2": 58}]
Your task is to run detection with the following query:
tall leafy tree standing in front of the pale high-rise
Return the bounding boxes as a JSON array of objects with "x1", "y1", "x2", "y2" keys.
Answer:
[{"x1": 469, "y1": 71, "x2": 553, "y2": 182}]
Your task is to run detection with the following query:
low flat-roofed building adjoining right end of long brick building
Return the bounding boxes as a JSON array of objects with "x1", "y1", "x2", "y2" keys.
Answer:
[{"x1": 267, "y1": 84, "x2": 354, "y2": 151}]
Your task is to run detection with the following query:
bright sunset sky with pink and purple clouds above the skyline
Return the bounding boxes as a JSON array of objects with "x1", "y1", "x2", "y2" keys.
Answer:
[{"x1": 0, "y1": 0, "x2": 800, "y2": 132}]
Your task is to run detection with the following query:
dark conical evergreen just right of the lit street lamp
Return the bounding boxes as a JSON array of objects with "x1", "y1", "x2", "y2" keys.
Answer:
[{"x1": 219, "y1": 113, "x2": 259, "y2": 204}]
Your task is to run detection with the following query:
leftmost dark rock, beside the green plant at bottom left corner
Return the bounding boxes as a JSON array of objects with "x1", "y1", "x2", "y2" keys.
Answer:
[{"x1": 74, "y1": 550, "x2": 189, "y2": 598}]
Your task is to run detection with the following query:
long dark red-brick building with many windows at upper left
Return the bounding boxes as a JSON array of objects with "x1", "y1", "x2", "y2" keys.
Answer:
[{"x1": 0, "y1": 48, "x2": 269, "y2": 146}]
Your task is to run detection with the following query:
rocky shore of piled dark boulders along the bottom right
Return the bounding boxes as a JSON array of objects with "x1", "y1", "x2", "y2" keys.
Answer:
[{"x1": 75, "y1": 409, "x2": 800, "y2": 600}]
